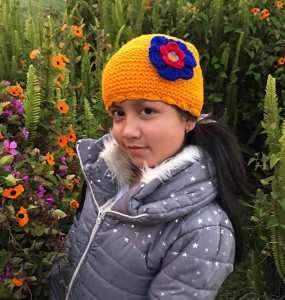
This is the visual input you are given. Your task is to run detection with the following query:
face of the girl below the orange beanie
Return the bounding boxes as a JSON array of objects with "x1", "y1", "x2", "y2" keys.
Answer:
[{"x1": 110, "y1": 100, "x2": 195, "y2": 168}]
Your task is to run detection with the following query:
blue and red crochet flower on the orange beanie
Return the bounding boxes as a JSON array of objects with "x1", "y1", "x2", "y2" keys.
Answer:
[{"x1": 148, "y1": 36, "x2": 197, "y2": 81}]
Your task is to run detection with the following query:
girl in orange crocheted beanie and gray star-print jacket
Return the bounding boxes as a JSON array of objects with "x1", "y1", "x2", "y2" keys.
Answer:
[{"x1": 50, "y1": 34, "x2": 251, "y2": 300}]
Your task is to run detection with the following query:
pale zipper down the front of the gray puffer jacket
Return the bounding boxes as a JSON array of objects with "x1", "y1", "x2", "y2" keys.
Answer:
[{"x1": 65, "y1": 199, "x2": 113, "y2": 300}]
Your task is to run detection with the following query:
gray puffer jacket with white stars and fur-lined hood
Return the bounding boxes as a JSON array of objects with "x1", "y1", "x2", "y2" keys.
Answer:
[{"x1": 50, "y1": 135, "x2": 235, "y2": 300}]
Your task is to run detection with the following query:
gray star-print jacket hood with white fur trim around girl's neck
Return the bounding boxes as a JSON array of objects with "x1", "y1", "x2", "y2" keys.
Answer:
[{"x1": 77, "y1": 134, "x2": 217, "y2": 223}]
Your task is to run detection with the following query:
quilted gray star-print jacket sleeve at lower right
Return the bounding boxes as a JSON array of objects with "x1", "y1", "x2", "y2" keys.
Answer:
[{"x1": 148, "y1": 225, "x2": 235, "y2": 300}]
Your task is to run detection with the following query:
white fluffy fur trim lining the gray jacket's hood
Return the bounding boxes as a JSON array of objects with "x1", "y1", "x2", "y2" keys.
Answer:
[{"x1": 100, "y1": 137, "x2": 201, "y2": 187}]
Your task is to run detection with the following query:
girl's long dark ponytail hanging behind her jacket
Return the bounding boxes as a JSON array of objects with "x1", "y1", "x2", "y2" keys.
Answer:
[{"x1": 176, "y1": 108, "x2": 253, "y2": 264}]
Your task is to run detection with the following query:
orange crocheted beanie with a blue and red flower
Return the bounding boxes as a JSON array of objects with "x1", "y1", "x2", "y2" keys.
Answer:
[{"x1": 102, "y1": 34, "x2": 204, "y2": 117}]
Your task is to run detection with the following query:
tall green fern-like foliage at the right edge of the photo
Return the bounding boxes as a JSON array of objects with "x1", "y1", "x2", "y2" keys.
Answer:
[{"x1": 248, "y1": 75, "x2": 285, "y2": 296}]
